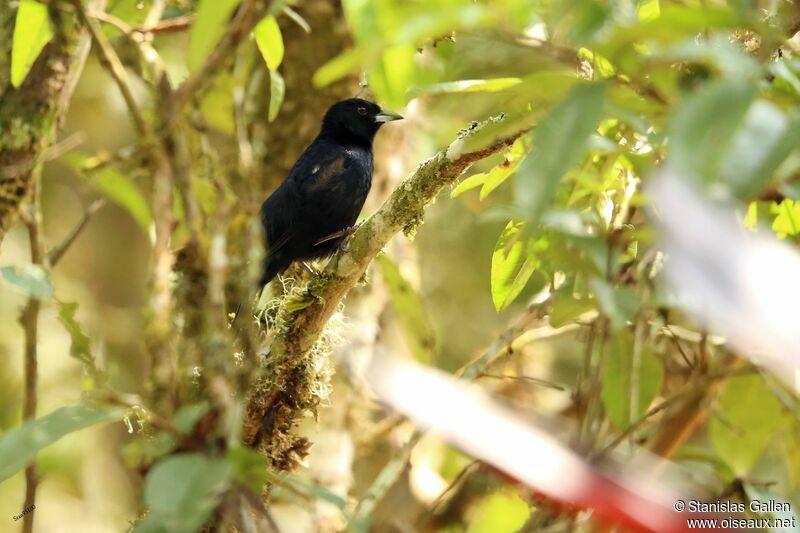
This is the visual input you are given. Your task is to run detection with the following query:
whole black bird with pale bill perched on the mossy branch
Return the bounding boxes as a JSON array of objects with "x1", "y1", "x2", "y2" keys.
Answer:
[{"x1": 260, "y1": 98, "x2": 403, "y2": 287}]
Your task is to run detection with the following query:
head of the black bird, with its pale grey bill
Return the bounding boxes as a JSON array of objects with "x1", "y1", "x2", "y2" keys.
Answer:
[{"x1": 322, "y1": 98, "x2": 403, "y2": 143}]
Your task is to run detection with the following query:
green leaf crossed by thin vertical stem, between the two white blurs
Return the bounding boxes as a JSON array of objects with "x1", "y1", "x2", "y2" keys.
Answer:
[{"x1": 601, "y1": 331, "x2": 664, "y2": 430}]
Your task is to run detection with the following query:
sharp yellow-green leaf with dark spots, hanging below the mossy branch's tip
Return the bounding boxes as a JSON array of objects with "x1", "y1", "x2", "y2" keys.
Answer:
[{"x1": 492, "y1": 220, "x2": 548, "y2": 313}]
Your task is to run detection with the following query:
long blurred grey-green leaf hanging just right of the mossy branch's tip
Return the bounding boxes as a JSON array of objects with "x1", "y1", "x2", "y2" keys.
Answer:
[{"x1": 516, "y1": 83, "x2": 605, "y2": 220}]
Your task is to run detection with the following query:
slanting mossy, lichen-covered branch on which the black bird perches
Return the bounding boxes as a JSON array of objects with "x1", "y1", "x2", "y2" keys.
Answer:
[{"x1": 243, "y1": 117, "x2": 526, "y2": 469}]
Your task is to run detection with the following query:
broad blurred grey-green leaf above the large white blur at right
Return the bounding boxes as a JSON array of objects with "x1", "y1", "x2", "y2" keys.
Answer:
[{"x1": 668, "y1": 80, "x2": 756, "y2": 183}]
